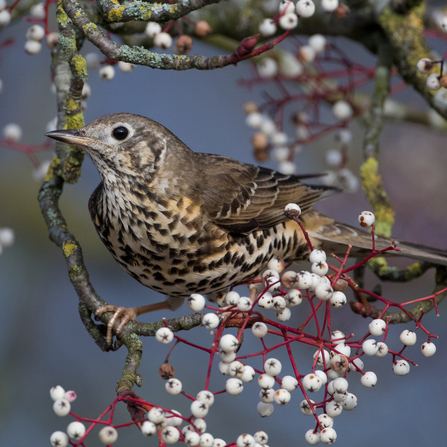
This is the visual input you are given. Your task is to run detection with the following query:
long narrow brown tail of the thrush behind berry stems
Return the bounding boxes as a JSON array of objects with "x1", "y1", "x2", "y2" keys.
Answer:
[{"x1": 309, "y1": 215, "x2": 447, "y2": 265}]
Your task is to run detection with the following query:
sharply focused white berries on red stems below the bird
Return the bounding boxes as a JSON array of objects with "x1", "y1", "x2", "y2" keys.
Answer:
[{"x1": 52, "y1": 210, "x2": 445, "y2": 447}]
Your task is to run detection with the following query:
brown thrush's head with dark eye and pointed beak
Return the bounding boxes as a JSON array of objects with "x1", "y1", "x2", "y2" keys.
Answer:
[{"x1": 46, "y1": 113, "x2": 183, "y2": 179}]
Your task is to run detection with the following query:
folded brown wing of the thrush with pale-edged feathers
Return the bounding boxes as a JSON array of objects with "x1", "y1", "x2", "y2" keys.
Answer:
[{"x1": 197, "y1": 154, "x2": 338, "y2": 233}]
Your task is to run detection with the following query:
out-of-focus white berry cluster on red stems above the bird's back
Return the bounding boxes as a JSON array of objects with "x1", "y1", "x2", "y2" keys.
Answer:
[{"x1": 240, "y1": 34, "x2": 374, "y2": 192}]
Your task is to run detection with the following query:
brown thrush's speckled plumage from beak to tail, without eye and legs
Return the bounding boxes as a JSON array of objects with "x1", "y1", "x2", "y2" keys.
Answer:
[{"x1": 44, "y1": 113, "x2": 447, "y2": 297}]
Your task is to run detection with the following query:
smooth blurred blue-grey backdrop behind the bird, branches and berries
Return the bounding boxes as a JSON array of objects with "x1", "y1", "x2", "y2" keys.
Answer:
[{"x1": 0, "y1": 7, "x2": 447, "y2": 447}]
